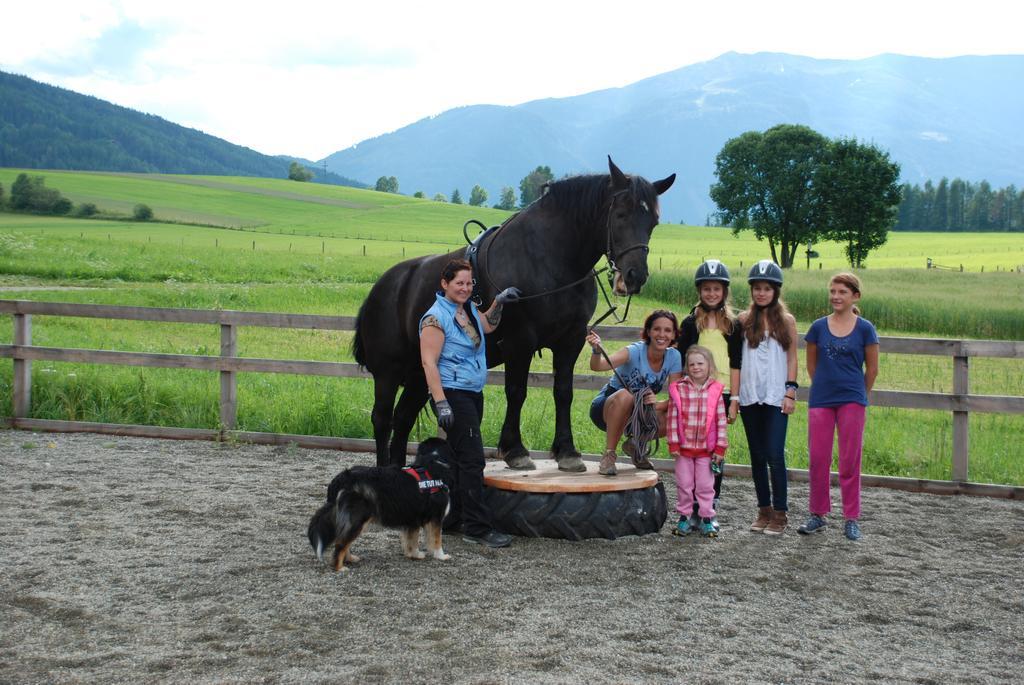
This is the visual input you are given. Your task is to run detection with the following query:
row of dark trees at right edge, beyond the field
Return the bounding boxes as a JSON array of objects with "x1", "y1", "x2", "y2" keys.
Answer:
[{"x1": 893, "y1": 178, "x2": 1024, "y2": 231}]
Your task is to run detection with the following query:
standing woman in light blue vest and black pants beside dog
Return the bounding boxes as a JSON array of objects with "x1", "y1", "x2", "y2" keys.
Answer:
[{"x1": 420, "y1": 259, "x2": 519, "y2": 547}]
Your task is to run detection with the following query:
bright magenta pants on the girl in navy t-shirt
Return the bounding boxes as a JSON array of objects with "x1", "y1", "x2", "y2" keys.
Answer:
[{"x1": 807, "y1": 402, "x2": 866, "y2": 520}]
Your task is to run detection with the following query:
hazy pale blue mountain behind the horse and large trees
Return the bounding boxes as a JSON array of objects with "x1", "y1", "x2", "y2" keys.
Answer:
[{"x1": 327, "y1": 52, "x2": 1024, "y2": 223}]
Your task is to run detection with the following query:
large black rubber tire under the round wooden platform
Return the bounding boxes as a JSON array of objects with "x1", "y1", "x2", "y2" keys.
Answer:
[{"x1": 483, "y1": 483, "x2": 669, "y2": 540}]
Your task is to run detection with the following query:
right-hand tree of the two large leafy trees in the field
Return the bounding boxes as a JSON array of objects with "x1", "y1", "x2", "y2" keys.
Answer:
[{"x1": 815, "y1": 138, "x2": 901, "y2": 268}]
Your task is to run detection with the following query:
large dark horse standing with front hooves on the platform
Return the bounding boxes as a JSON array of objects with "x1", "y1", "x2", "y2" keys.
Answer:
[{"x1": 352, "y1": 158, "x2": 676, "y2": 470}]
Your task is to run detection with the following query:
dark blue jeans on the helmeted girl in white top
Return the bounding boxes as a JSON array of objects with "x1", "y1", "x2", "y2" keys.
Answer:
[{"x1": 739, "y1": 404, "x2": 790, "y2": 511}]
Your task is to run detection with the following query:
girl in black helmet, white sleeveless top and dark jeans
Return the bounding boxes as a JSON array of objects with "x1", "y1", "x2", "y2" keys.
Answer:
[{"x1": 739, "y1": 259, "x2": 799, "y2": 536}]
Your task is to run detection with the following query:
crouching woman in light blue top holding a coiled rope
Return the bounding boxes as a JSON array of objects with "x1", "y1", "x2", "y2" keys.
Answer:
[{"x1": 587, "y1": 309, "x2": 683, "y2": 476}]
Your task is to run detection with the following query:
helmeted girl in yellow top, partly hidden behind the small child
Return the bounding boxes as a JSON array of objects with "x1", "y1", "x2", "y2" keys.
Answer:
[{"x1": 676, "y1": 259, "x2": 742, "y2": 530}]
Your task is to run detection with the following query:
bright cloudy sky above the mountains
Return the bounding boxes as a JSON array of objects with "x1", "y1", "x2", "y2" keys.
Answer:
[{"x1": 0, "y1": 0, "x2": 1024, "y2": 160}]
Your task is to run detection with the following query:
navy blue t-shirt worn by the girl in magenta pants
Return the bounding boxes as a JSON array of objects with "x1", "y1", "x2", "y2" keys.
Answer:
[{"x1": 804, "y1": 316, "x2": 879, "y2": 408}]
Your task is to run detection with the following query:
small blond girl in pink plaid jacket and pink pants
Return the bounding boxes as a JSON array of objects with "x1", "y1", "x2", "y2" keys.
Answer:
[{"x1": 667, "y1": 345, "x2": 729, "y2": 538}]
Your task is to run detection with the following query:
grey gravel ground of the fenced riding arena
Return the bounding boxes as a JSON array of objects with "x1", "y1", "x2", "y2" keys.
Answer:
[{"x1": 0, "y1": 430, "x2": 1024, "y2": 683}]
